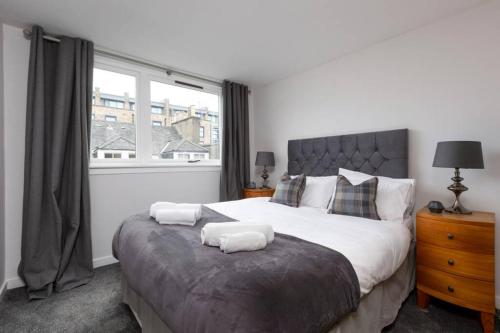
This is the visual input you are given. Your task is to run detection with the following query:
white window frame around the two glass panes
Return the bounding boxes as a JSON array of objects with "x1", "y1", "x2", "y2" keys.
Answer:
[{"x1": 90, "y1": 54, "x2": 223, "y2": 174}]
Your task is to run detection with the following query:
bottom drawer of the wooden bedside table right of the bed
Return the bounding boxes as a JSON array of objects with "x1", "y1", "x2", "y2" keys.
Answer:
[{"x1": 417, "y1": 265, "x2": 495, "y2": 313}]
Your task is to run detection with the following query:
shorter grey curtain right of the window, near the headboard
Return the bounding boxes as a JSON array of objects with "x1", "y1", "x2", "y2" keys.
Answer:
[{"x1": 220, "y1": 81, "x2": 250, "y2": 201}]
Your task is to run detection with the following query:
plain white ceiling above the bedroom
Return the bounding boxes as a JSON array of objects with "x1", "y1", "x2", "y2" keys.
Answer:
[{"x1": 0, "y1": 0, "x2": 485, "y2": 85}]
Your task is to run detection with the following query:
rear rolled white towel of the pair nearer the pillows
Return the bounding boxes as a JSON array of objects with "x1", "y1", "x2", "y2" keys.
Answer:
[{"x1": 201, "y1": 222, "x2": 274, "y2": 246}]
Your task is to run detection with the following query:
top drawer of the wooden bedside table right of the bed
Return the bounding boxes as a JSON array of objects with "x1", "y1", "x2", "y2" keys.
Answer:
[{"x1": 417, "y1": 218, "x2": 495, "y2": 254}]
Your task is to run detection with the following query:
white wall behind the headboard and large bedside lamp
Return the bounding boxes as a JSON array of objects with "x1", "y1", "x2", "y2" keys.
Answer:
[{"x1": 252, "y1": 0, "x2": 500, "y2": 307}]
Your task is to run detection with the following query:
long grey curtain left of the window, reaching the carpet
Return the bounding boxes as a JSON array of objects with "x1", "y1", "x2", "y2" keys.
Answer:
[{"x1": 18, "y1": 27, "x2": 94, "y2": 299}]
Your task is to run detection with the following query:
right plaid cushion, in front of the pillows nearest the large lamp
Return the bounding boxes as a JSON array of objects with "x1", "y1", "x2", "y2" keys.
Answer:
[{"x1": 328, "y1": 175, "x2": 380, "y2": 220}]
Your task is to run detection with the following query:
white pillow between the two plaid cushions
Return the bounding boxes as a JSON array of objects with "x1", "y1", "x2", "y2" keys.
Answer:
[{"x1": 300, "y1": 176, "x2": 337, "y2": 209}]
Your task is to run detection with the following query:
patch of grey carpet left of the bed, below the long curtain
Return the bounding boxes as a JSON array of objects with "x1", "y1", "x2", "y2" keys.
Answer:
[{"x1": 0, "y1": 264, "x2": 140, "y2": 332}]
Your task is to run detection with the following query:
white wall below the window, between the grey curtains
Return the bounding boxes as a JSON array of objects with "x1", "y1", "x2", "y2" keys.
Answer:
[{"x1": 90, "y1": 170, "x2": 219, "y2": 264}]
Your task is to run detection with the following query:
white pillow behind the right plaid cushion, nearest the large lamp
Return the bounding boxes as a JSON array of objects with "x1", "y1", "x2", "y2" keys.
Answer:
[{"x1": 339, "y1": 168, "x2": 415, "y2": 223}]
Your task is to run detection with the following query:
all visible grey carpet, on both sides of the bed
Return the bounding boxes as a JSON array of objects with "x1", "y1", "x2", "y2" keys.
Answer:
[{"x1": 0, "y1": 264, "x2": 498, "y2": 333}]
